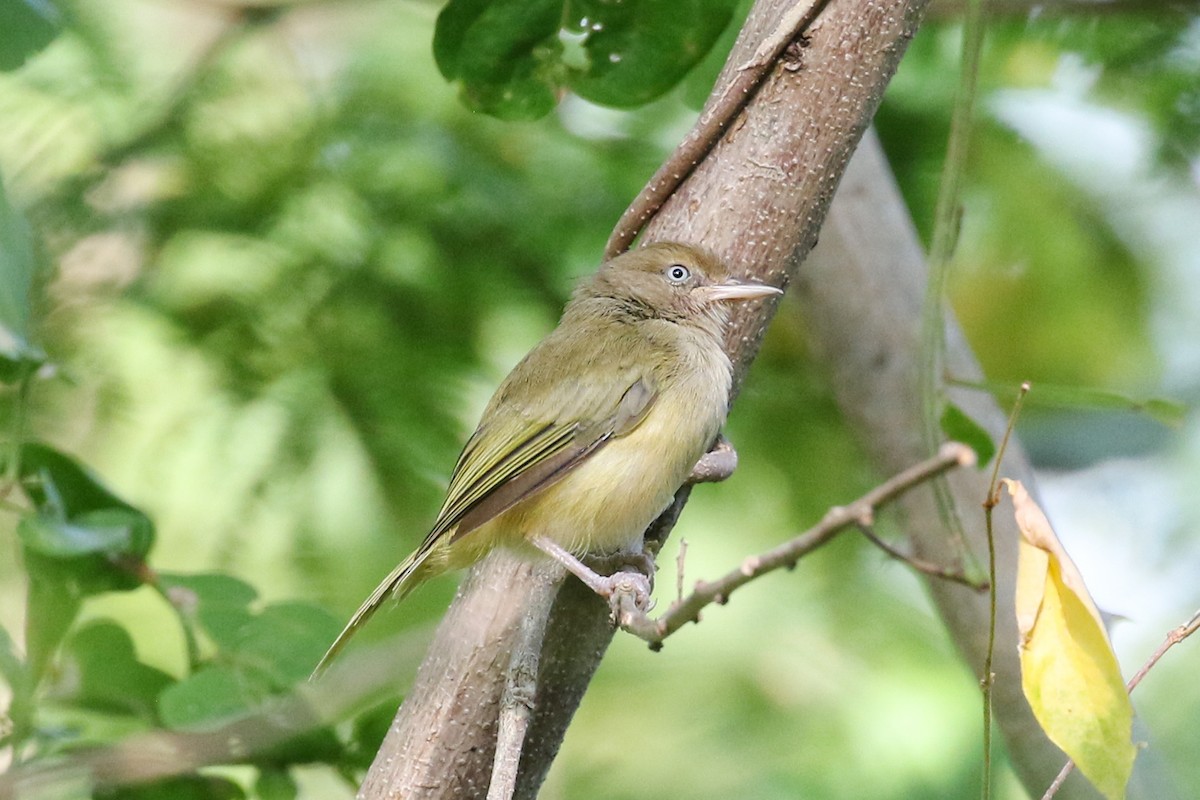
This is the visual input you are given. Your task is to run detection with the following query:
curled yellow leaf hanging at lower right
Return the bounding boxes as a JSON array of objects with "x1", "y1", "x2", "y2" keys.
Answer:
[{"x1": 1004, "y1": 481, "x2": 1136, "y2": 800}]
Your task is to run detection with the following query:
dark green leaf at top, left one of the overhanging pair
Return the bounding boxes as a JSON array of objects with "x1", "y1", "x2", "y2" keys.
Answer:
[{"x1": 433, "y1": 0, "x2": 563, "y2": 120}]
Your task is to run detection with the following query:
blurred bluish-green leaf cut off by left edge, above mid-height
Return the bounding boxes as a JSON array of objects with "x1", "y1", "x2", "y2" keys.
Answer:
[{"x1": 0, "y1": 176, "x2": 46, "y2": 383}]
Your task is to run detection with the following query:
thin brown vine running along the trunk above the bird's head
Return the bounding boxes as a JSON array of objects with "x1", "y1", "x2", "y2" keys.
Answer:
[{"x1": 605, "y1": 0, "x2": 827, "y2": 259}]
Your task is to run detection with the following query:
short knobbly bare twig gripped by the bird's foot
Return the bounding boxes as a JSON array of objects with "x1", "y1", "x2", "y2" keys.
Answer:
[{"x1": 617, "y1": 441, "x2": 976, "y2": 649}]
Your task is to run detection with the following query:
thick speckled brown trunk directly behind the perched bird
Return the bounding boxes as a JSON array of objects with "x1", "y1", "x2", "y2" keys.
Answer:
[{"x1": 360, "y1": 0, "x2": 945, "y2": 800}]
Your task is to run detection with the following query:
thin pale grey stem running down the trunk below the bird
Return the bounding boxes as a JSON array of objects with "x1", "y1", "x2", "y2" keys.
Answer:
[{"x1": 487, "y1": 563, "x2": 559, "y2": 800}]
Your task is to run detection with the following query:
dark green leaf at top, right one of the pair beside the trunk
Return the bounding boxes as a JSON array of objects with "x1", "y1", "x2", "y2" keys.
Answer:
[{"x1": 570, "y1": 0, "x2": 736, "y2": 107}]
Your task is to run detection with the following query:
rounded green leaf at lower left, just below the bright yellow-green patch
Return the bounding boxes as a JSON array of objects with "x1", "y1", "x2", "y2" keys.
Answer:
[{"x1": 64, "y1": 620, "x2": 174, "y2": 722}]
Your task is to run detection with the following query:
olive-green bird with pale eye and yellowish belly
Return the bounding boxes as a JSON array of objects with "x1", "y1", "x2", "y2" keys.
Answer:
[{"x1": 317, "y1": 242, "x2": 780, "y2": 672}]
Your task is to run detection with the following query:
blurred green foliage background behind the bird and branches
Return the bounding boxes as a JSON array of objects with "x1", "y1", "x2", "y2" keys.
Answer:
[{"x1": 0, "y1": 0, "x2": 1200, "y2": 799}]
